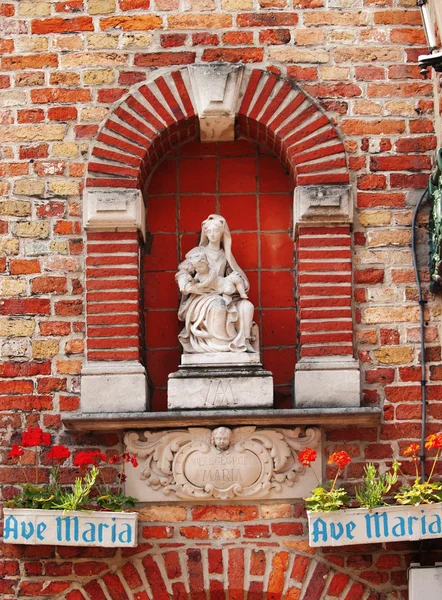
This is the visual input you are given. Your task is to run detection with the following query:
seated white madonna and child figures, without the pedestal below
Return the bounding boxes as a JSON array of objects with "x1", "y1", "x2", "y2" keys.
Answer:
[{"x1": 176, "y1": 215, "x2": 258, "y2": 354}]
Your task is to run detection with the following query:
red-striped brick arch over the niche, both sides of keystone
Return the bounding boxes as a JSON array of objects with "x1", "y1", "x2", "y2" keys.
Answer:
[{"x1": 87, "y1": 67, "x2": 349, "y2": 190}]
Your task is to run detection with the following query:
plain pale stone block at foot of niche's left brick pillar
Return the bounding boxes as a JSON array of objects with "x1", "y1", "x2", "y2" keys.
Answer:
[{"x1": 81, "y1": 361, "x2": 149, "y2": 413}]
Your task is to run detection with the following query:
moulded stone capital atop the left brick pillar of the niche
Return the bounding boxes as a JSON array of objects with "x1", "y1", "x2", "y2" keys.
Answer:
[{"x1": 83, "y1": 190, "x2": 146, "y2": 239}]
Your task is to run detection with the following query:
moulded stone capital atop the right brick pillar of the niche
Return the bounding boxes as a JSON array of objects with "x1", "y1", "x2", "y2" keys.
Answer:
[{"x1": 293, "y1": 185, "x2": 353, "y2": 227}]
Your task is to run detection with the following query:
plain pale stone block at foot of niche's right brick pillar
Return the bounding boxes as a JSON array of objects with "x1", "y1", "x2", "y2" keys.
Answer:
[{"x1": 295, "y1": 357, "x2": 361, "y2": 408}]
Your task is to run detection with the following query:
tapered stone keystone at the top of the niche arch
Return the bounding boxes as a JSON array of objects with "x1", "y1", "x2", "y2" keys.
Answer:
[{"x1": 187, "y1": 64, "x2": 244, "y2": 142}]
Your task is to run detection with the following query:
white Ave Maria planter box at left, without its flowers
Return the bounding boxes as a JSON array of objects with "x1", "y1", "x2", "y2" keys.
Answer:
[{"x1": 3, "y1": 508, "x2": 138, "y2": 548}]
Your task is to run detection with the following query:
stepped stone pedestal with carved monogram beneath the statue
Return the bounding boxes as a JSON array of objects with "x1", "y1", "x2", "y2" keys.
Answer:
[{"x1": 167, "y1": 352, "x2": 273, "y2": 410}]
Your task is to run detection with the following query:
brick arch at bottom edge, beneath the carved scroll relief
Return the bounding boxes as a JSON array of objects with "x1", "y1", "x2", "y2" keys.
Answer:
[{"x1": 60, "y1": 542, "x2": 390, "y2": 600}]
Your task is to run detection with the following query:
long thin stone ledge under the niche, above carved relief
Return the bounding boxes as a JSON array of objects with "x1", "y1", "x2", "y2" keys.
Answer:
[{"x1": 63, "y1": 407, "x2": 382, "y2": 431}]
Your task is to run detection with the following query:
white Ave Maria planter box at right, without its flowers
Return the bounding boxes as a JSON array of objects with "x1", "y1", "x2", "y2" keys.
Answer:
[{"x1": 307, "y1": 503, "x2": 442, "y2": 547}]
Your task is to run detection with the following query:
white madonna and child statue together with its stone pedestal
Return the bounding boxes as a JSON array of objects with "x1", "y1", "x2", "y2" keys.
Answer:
[{"x1": 168, "y1": 214, "x2": 273, "y2": 410}]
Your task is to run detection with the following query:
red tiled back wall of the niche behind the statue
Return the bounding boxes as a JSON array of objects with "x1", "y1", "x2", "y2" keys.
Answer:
[{"x1": 144, "y1": 139, "x2": 296, "y2": 411}]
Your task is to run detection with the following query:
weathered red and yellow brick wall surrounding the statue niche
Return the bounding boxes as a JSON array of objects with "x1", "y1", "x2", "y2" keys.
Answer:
[{"x1": 0, "y1": 0, "x2": 442, "y2": 600}]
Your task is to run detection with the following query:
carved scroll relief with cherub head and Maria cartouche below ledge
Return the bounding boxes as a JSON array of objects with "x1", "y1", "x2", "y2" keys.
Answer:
[{"x1": 124, "y1": 426, "x2": 320, "y2": 500}]
